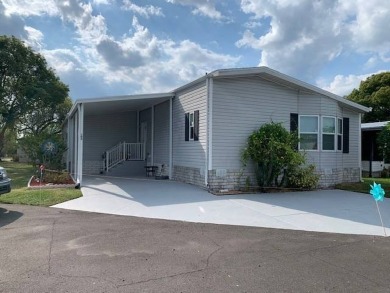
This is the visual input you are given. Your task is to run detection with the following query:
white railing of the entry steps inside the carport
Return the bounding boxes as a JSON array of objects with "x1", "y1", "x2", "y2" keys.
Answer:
[{"x1": 103, "y1": 142, "x2": 145, "y2": 172}]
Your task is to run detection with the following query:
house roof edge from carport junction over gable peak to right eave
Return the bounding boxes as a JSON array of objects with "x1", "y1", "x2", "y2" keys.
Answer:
[{"x1": 173, "y1": 66, "x2": 370, "y2": 113}]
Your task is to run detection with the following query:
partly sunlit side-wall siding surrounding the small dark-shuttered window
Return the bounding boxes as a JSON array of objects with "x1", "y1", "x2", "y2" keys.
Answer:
[{"x1": 173, "y1": 81, "x2": 207, "y2": 171}]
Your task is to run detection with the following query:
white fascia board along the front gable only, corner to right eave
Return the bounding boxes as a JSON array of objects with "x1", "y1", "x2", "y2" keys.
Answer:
[{"x1": 210, "y1": 66, "x2": 371, "y2": 113}]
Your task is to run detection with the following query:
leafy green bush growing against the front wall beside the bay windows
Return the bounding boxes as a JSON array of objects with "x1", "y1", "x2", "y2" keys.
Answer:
[{"x1": 241, "y1": 122, "x2": 318, "y2": 188}]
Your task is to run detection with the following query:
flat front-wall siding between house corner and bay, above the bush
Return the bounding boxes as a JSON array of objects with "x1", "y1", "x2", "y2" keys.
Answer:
[{"x1": 212, "y1": 77, "x2": 297, "y2": 170}]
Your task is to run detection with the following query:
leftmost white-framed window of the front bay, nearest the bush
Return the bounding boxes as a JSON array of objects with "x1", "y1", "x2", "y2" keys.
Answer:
[{"x1": 298, "y1": 115, "x2": 318, "y2": 150}]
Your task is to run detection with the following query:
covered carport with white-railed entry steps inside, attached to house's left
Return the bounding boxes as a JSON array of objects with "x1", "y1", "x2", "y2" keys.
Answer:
[{"x1": 65, "y1": 93, "x2": 173, "y2": 184}]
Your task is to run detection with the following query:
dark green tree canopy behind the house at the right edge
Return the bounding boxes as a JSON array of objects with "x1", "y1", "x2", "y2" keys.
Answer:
[{"x1": 347, "y1": 72, "x2": 390, "y2": 122}]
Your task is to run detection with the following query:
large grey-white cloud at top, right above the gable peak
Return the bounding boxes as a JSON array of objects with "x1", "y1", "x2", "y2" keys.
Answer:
[{"x1": 236, "y1": 0, "x2": 349, "y2": 79}]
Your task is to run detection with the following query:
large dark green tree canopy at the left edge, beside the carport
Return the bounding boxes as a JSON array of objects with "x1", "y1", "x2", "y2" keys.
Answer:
[{"x1": 0, "y1": 36, "x2": 69, "y2": 149}]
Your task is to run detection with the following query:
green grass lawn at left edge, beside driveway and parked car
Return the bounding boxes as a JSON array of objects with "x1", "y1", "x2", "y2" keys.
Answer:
[{"x1": 0, "y1": 161, "x2": 82, "y2": 206}]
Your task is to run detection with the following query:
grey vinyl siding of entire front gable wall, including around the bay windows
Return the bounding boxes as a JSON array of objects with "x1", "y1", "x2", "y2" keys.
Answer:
[{"x1": 212, "y1": 78, "x2": 360, "y2": 181}]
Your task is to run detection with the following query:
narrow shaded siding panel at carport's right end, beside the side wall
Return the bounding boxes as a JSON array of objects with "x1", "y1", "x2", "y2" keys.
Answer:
[{"x1": 153, "y1": 101, "x2": 169, "y2": 166}]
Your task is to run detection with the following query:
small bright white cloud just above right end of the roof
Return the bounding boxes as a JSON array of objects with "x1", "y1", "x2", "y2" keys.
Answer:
[{"x1": 317, "y1": 70, "x2": 384, "y2": 96}]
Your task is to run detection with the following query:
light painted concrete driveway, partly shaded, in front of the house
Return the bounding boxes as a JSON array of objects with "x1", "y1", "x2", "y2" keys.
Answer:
[{"x1": 54, "y1": 177, "x2": 390, "y2": 236}]
